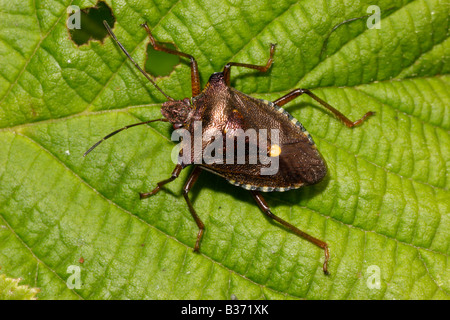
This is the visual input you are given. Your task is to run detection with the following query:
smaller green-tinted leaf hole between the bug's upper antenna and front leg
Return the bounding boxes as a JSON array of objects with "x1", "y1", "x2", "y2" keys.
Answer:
[{"x1": 144, "y1": 43, "x2": 180, "y2": 77}]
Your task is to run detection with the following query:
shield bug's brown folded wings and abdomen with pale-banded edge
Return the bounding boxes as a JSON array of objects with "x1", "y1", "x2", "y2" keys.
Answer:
[{"x1": 204, "y1": 88, "x2": 327, "y2": 191}]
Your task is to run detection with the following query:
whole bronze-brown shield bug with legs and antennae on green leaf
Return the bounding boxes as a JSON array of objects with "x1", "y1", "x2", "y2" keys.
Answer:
[{"x1": 84, "y1": 21, "x2": 374, "y2": 274}]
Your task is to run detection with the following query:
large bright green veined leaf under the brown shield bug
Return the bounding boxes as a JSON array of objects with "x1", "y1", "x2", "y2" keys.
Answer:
[{"x1": 0, "y1": 0, "x2": 450, "y2": 299}]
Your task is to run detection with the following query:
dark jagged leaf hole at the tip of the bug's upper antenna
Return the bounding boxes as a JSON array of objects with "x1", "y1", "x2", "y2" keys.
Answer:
[{"x1": 68, "y1": 1, "x2": 116, "y2": 46}]
